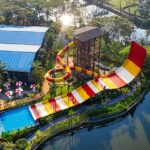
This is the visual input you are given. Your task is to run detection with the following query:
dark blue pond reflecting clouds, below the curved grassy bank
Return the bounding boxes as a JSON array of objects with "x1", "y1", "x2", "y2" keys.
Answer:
[{"x1": 40, "y1": 90, "x2": 150, "y2": 150}]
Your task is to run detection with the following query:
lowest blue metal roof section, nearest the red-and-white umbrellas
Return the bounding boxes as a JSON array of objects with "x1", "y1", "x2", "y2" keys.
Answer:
[{"x1": 0, "y1": 51, "x2": 36, "y2": 72}]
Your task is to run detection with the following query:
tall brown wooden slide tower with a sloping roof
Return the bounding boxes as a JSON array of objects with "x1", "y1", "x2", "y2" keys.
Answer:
[{"x1": 73, "y1": 26, "x2": 102, "y2": 72}]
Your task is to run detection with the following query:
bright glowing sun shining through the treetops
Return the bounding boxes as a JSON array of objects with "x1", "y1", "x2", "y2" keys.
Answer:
[{"x1": 60, "y1": 14, "x2": 73, "y2": 26}]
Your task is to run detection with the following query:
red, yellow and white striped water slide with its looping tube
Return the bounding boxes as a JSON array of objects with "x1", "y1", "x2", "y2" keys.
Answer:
[{"x1": 29, "y1": 41, "x2": 146, "y2": 120}]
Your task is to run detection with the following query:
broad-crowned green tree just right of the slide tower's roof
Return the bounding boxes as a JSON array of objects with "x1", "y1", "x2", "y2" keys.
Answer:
[{"x1": 90, "y1": 16, "x2": 133, "y2": 49}]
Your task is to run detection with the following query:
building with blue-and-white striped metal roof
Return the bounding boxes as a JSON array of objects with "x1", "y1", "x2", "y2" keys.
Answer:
[{"x1": 0, "y1": 25, "x2": 48, "y2": 82}]
